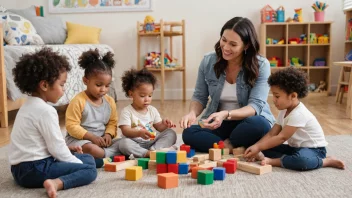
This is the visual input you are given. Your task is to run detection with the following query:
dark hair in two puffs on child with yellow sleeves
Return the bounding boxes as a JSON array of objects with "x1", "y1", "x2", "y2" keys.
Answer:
[{"x1": 78, "y1": 49, "x2": 115, "y2": 77}]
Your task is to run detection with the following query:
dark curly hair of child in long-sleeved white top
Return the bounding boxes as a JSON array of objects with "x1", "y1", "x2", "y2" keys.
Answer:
[{"x1": 12, "y1": 47, "x2": 71, "y2": 95}]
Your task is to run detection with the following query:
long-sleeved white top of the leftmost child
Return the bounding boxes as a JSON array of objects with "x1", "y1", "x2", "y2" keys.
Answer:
[{"x1": 8, "y1": 96, "x2": 82, "y2": 165}]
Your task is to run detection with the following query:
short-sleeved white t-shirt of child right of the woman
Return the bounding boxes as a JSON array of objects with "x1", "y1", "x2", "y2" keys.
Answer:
[{"x1": 276, "y1": 102, "x2": 327, "y2": 148}]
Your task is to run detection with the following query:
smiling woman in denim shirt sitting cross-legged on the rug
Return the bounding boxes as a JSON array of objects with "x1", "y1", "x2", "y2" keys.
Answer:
[{"x1": 180, "y1": 17, "x2": 274, "y2": 152}]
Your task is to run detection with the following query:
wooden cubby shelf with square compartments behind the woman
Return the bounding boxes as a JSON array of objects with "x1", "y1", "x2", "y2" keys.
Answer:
[{"x1": 260, "y1": 22, "x2": 332, "y2": 95}]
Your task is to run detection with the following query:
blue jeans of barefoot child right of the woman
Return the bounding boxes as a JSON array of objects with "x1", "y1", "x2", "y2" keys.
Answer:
[{"x1": 263, "y1": 144, "x2": 326, "y2": 171}]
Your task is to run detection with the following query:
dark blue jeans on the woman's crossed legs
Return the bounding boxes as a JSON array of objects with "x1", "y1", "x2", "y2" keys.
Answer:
[{"x1": 182, "y1": 116, "x2": 271, "y2": 152}]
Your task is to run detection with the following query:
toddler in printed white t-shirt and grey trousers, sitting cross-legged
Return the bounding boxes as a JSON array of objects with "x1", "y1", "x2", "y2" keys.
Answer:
[{"x1": 119, "y1": 69, "x2": 177, "y2": 157}]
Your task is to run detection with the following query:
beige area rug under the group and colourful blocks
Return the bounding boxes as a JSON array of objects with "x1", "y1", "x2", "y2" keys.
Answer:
[{"x1": 0, "y1": 135, "x2": 352, "y2": 198}]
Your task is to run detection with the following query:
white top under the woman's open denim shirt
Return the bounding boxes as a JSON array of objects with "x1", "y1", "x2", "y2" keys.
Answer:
[{"x1": 219, "y1": 80, "x2": 240, "y2": 111}]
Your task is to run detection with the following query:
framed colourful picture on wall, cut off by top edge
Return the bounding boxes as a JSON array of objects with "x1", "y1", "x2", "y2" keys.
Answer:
[{"x1": 49, "y1": 0, "x2": 152, "y2": 13}]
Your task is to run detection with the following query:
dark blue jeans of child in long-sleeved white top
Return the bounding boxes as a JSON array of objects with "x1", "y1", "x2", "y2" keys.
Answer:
[{"x1": 11, "y1": 154, "x2": 97, "y2": 189}]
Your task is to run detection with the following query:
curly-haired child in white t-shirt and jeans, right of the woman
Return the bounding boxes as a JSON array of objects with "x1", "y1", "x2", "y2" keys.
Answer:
[{"x1": 244, "y1": 68, "x2": 344, "y2": 170}]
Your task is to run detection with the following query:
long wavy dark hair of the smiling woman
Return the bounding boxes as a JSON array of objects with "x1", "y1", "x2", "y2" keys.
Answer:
[{"x1": 214, "y1": 17, "x2": 259, "y2": 87}]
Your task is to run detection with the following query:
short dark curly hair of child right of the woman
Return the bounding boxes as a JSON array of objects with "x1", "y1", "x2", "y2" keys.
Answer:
[{"x1": 268, "y1": 67, "x2": 308, "y2": 98}]
